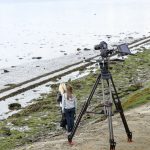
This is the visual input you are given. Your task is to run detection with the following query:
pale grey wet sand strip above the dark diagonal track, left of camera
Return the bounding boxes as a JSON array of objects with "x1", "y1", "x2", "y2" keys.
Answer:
[{"x1": 0, "y1": 50, "x2": 99, "y2": 89}]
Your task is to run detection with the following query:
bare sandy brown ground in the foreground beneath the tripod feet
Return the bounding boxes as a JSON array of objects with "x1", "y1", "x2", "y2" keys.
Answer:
[{"x1": 17, "y1": 103, "x2": 150, "y2": 150}]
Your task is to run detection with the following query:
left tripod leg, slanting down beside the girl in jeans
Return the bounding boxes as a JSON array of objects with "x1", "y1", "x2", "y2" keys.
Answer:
[{"x1": 68, "y1": 74, "x2": 101, "y2": 142}]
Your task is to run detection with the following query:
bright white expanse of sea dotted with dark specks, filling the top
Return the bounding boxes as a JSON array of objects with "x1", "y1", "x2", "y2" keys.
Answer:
[{"x1": 0, "y1": 0, "x2": 150, "y2": 69}]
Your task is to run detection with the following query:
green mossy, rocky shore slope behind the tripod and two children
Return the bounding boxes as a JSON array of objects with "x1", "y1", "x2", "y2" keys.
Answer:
[{"x1": 0, "y1": 45, "x2": 150, "y2": 150}]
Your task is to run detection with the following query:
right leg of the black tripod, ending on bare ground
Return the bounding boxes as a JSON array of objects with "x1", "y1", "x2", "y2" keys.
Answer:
[{"x1": 107, "y1": 76, "x2": 132, "y2": 142}]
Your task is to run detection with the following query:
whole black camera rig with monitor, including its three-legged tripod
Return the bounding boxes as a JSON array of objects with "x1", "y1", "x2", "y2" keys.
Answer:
[{"x1": 68, "y1": 41, "x2": 132, "y2": 150}]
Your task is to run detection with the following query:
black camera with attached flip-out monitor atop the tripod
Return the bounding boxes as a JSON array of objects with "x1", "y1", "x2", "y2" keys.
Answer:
[{"x1": 94, "y1": 41, "x2": 132, "y2": 58}]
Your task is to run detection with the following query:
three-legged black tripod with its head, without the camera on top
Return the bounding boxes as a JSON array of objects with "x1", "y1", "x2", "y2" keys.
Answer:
[{"x1": 68, "y1": 58, "x2": 132, "y2": 150}]
